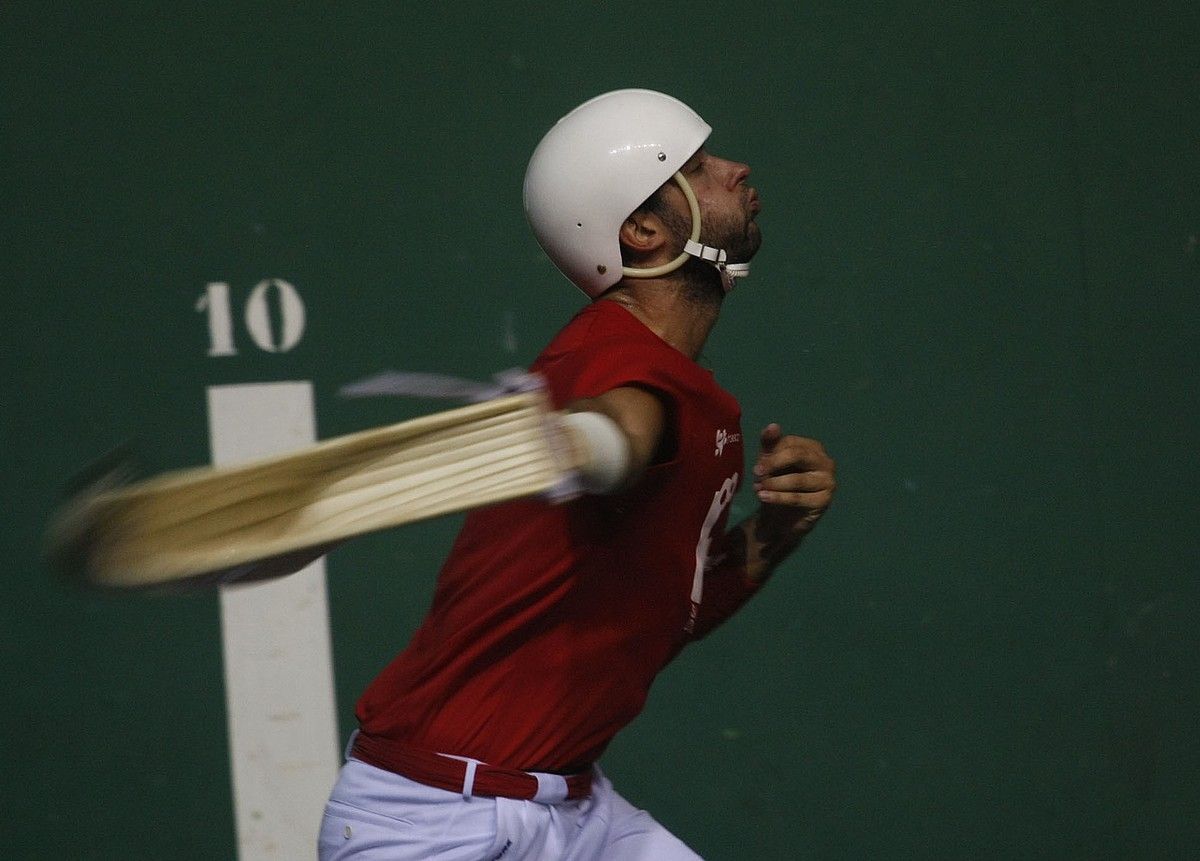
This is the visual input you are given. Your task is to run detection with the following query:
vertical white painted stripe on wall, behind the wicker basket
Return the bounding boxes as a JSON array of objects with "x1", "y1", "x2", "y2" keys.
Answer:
[{"x1": 208, "y1": 381, "x2": 340, "y2": 861}]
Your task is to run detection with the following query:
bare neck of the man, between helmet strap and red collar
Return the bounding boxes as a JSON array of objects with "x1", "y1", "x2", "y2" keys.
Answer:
[{"x1": 601, "y1": 278, "x2": 721, "y2": 360}]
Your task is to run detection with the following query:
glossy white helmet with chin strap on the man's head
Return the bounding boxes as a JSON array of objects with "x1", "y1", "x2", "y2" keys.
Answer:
[{"x1": 524, "y1": 90, "x2": 749, "y2": 299}]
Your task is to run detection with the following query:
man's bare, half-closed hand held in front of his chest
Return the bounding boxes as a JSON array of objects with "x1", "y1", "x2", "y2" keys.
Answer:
[{"x1": 754, "y1": 423, "x2": 836, "y2": 542}]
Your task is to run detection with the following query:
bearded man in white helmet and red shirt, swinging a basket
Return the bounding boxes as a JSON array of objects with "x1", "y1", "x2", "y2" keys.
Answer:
[{"x1": 320, "y1": 90, "x2": 834, "y2": 861}]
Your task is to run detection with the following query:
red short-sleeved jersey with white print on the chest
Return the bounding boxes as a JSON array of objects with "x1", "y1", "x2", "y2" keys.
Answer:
[{"x1": 358, "y1": 301, "x2": 754, "y2": 771}]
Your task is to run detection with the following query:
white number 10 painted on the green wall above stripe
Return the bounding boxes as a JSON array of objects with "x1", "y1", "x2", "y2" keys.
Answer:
[{"x1": 196, "y1": 278, "x2": 305, "y2": 356}]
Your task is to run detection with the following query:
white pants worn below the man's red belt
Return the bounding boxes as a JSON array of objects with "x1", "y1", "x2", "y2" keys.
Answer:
[{"x1": 319, "y1": 759, "x2": 700, "y2": 861}]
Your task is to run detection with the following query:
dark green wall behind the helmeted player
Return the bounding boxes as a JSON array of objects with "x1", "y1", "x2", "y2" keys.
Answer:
[{"x1": 0, "y1": 0, "x2": 1200, "y2": 859}]
